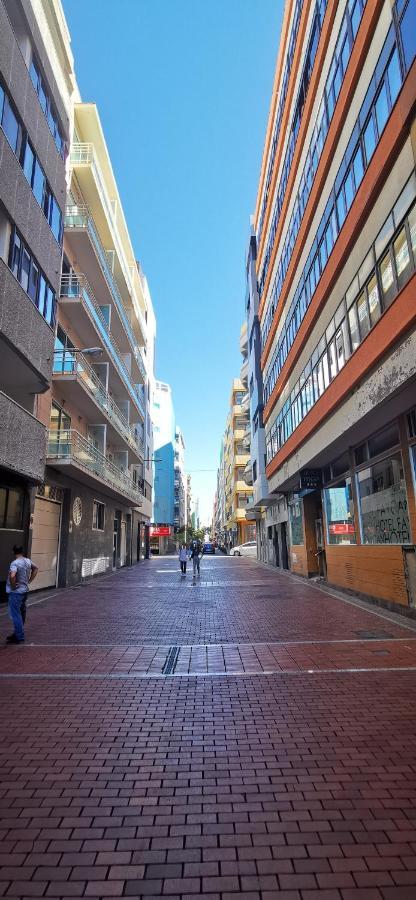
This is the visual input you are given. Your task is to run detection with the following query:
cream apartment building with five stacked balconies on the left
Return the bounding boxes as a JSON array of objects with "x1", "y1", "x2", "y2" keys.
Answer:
[{"x1": 32, "y1": 101, "x2": 154, "y2": 587}]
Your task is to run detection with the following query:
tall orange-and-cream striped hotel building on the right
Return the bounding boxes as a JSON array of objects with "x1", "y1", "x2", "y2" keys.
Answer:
[{"x1": 255, "y1": 0, "x2": 416, "y2": 606}]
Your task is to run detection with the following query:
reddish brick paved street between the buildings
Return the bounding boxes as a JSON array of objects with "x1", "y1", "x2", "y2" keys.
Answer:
[{"x1": 0, "y1": 557, "x2": 416, "y2": 900}]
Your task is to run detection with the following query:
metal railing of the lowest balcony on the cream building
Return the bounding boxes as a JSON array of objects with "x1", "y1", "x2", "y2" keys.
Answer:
[{"x1": 47, "y1": 429, "x2": 143, "y2": 506}]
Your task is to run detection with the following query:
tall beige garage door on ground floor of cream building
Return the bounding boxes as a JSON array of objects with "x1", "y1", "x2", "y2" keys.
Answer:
[{"x1": 31, "y1": 497, "x2": 61, "y2": 591}]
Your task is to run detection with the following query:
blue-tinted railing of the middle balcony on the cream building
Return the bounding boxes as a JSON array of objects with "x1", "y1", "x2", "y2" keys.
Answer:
[{"x1": 60, "y1": 273, "x2": 144, "y2": 417}]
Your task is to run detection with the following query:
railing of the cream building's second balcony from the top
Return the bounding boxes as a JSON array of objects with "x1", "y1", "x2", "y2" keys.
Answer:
[{"x1": 65, "y1": 206, "x2": 145, "y2": 358}]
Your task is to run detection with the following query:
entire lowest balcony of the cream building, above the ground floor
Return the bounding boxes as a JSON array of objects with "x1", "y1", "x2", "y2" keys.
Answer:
[{"x1": 47, "y1": 429, "x2": 143, "y2": 506}]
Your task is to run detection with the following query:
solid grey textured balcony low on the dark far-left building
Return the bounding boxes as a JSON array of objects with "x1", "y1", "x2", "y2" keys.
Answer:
[{"x1": 0, "y1": 391, "x2": 46, "y2": 483}]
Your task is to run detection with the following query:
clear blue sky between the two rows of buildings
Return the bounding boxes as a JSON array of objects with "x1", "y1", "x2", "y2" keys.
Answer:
[{"x1": 63, "y1": 0, "x2": 283, "y2": 521}]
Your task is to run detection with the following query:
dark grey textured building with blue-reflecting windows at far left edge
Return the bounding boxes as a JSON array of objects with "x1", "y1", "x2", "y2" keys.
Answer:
[{"x1": 0, "y1": 0, "x2": 74, "y2": 588}]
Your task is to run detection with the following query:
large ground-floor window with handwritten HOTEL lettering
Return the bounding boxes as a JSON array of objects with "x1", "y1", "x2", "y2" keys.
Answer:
[{"x1": 357, "y1": 452, "x2": 410, "y2": 544}]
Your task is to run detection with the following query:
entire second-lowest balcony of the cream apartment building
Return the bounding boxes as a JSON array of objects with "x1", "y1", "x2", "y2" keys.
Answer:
[{"x1": 53, "y1": 350, "x2": 144, "y2": 464}]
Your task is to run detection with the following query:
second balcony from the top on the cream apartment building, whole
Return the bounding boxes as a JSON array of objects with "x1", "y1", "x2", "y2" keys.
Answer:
[{"x1": 65, "y1": 206, "x2": 146, "y2": 348}]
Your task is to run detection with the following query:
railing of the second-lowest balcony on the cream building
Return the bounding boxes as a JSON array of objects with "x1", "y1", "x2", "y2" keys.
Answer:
[{"x1": 53, "y1": 350, "x2": 144, "y2": 455}]
